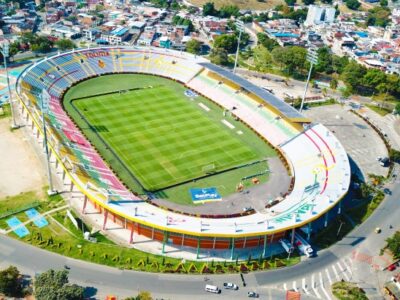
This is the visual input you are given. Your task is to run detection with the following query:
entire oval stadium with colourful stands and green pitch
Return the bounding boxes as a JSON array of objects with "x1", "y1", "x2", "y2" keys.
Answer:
[{"x1": 17, "y1": 46, "x2": 350, "y2": 258}]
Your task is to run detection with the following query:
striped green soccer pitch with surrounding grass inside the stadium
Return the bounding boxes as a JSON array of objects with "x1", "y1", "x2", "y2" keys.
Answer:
[{"x1": 64, "y1": 74, "x2": 275, "y2": 203}]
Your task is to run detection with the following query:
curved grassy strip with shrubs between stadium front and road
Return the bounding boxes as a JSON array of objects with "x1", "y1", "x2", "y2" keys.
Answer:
[{"x1": 10, "y1": 207, "x2": 300, "y2": 274}]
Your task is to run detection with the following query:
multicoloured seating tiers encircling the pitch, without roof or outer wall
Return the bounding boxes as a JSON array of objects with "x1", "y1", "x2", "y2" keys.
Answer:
[{"x1": 18, "y1": 47, "x2": 350, "y2": 239}]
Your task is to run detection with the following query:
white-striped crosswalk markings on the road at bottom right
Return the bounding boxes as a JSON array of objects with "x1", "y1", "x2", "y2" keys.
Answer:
[{"x1": 278, "y1": 257, "x2": 353, "y2": 300}]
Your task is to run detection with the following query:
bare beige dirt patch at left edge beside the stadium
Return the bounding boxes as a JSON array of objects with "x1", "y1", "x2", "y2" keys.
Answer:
[{"x1": 0, "y1": 118, "x2": 46, "y2": 199}]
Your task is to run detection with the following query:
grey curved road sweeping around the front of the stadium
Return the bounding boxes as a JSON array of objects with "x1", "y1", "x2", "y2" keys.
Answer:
[{"x1": 0, "y1": 168, "x2": 400, "y2": 299}]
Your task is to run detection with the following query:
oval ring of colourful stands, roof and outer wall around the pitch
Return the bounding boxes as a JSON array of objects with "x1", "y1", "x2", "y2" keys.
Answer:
[{"x1": 17, "y1": 47, "x2": 350, "y2": 253}]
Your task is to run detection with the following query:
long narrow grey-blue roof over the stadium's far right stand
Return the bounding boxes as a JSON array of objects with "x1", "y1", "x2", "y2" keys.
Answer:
[{"x1": 199, "y1": 62, "x2": 307, "y2": 120}]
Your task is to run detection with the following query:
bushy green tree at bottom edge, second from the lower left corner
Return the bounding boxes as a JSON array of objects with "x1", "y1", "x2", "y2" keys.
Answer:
[{"x1": 34, "y1": 270, "x2": 84, "y2": 300}]
